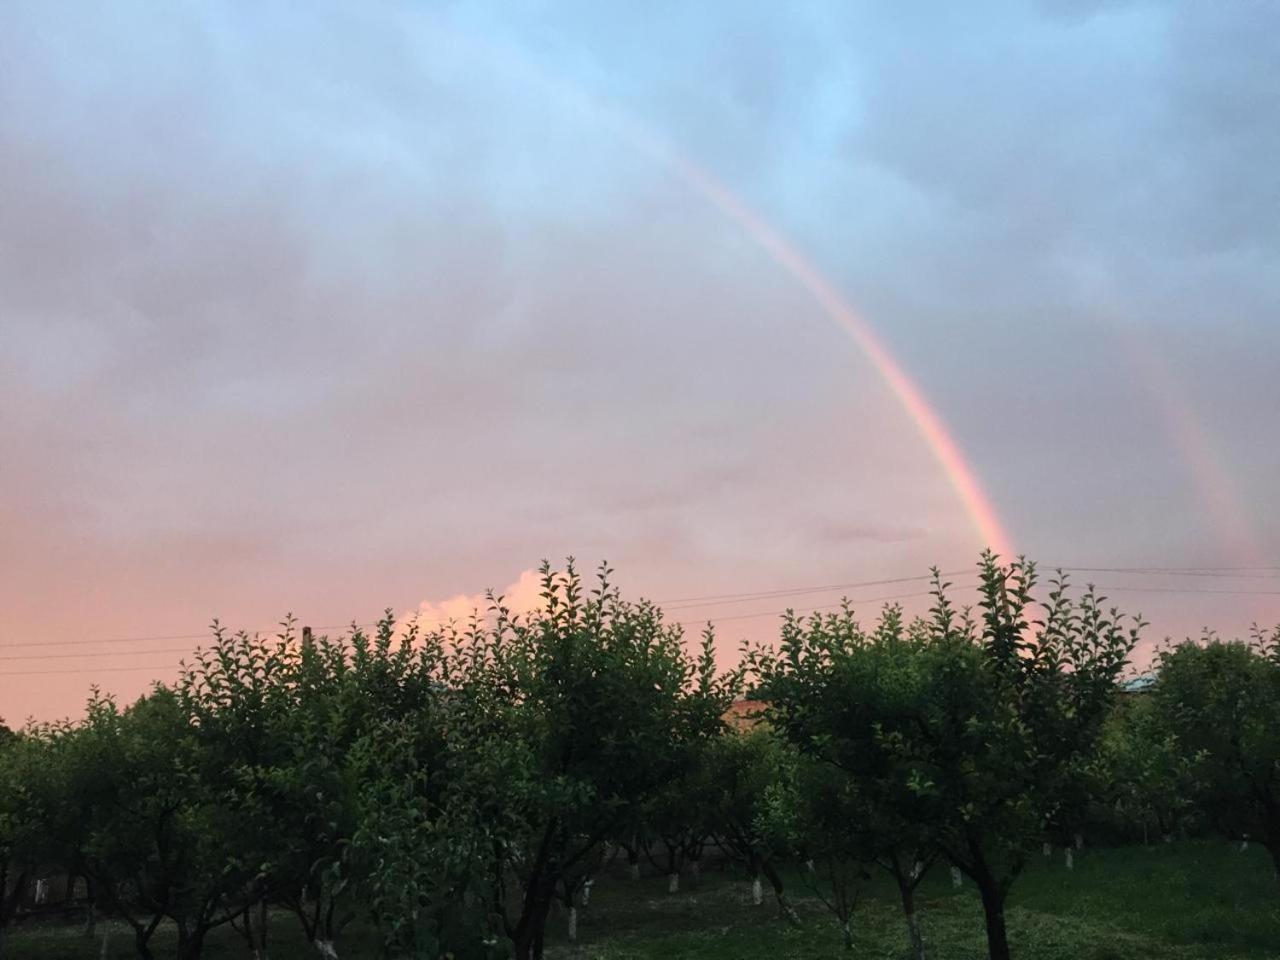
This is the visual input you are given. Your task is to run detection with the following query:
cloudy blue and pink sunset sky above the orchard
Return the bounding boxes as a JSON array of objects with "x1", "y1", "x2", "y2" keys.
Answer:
[{"x1": 0, "y1": 0, "x2": 1280, "y2": 724}]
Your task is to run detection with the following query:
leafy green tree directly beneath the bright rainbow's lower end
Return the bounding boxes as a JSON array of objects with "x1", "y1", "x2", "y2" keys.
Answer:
[{"x1": 753, "y1": 553, "x2": 1138, "y2": 960}]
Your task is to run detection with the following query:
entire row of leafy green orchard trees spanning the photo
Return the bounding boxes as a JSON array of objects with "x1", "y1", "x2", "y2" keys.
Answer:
[{"x1": 20, "y1": 556, "x2": 1280, "y2": 960}]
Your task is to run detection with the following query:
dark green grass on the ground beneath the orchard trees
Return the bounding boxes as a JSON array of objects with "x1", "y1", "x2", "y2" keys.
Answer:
[{"x1": 0, "y1": 841, "x2": 1280, "y2": 960}]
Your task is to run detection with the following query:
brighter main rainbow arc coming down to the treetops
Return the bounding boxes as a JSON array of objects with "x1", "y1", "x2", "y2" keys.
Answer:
[{"x1": 414, "y1": 17, "x2": 1014, "y2": 557}]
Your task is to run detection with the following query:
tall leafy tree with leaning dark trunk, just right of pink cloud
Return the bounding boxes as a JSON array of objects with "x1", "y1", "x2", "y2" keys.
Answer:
[{"x1": 445, "y1": 561, "x2": 731, "y2": 960}]
